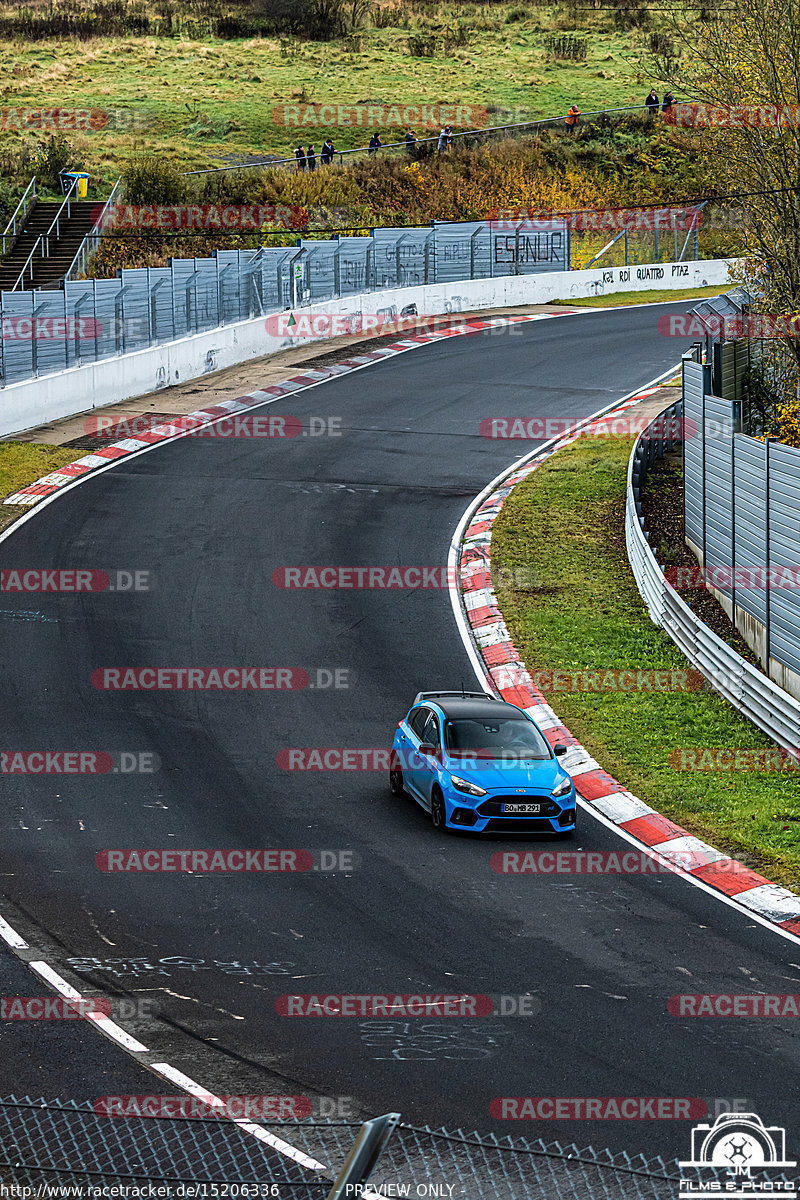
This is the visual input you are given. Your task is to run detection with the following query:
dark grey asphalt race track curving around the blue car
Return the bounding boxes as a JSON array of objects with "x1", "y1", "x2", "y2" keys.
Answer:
[{"x1": 0, "y1": 306, "x2": 800, "y2": 1158}]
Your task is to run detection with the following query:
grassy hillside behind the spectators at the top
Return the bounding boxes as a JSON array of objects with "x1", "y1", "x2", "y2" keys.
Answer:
[{"x1": 0, "y1": 0, "x2": 690, "y2": 184}]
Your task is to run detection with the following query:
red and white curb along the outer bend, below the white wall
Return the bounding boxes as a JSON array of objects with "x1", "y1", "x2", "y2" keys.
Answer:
[{"x1": 4, "y1": 308, "x2": 575, "y2": 506}]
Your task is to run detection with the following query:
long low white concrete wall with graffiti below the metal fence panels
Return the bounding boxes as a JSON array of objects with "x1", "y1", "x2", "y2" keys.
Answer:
[{"x1": 0, "y1": 259, "x2": 728, "y2": 437}]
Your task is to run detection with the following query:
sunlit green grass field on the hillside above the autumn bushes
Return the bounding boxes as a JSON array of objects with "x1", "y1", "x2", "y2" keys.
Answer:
[{"x1": 0, "y1": 5, "x2": 662, "y2": 182}]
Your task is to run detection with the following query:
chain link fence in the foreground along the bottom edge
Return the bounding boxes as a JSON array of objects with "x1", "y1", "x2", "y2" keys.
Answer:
[{"x1": 0, "y1": 1096, "x2": 694, "y2": 1200}]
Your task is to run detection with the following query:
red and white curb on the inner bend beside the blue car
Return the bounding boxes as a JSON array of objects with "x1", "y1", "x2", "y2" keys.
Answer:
[{"x1": 451, "y1": 370, "x2": 800, "y2": 941}]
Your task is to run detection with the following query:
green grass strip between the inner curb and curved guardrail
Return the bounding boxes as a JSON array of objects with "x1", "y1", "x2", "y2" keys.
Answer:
[{"x1": 492, "y1": 440, "x2": 800, "y2": 888}]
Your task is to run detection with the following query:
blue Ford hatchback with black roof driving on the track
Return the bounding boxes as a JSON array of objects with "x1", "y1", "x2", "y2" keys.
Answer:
[{"x1": 389, "y1": 691, "x2": 576, "y2": 836}]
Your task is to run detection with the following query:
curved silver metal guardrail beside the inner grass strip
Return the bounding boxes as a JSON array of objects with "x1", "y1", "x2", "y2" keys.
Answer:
[{"x1": 625, "y1": 400, "x2": 800, "y2": 749}]
